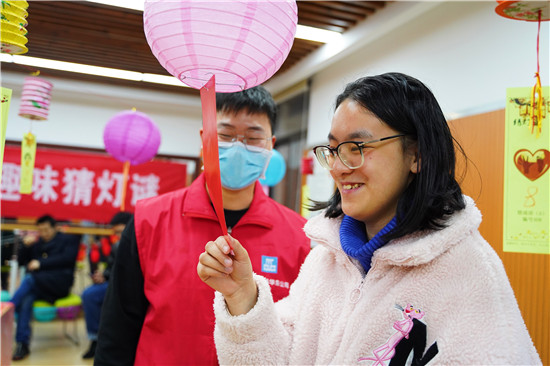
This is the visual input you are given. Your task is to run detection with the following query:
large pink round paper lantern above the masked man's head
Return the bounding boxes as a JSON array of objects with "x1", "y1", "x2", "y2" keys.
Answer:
[{"x1": 143, "y1": 0, "x2": 298, "y2": 92}]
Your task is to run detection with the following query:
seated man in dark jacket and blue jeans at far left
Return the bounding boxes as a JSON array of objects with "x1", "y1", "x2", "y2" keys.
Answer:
[{"x1": 11, "y1": 215, "x2": 80, "y2": 360}]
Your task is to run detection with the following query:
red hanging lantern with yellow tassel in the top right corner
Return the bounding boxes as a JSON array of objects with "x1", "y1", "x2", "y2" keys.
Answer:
[{"x1": 495, "y1": 0, "x2": 550, "y2": 137}]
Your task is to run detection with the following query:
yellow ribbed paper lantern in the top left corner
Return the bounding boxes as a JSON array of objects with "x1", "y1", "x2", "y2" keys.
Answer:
[{"x1": 0, "y1": 0, "x2": 29, "y2": 55}]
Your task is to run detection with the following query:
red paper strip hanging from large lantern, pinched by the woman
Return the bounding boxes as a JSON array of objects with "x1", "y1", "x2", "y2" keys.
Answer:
[{"x1": 201, "y1": 75, "x2": 231, "y2": 237}]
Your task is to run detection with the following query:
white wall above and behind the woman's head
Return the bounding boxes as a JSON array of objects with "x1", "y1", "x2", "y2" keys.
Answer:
[{"x1": 307, "y1": 1, "x2": 550, "y2": 146}]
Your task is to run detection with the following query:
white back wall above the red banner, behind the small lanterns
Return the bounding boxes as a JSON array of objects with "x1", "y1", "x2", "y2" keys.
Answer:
[{"x1": 1, "y1": 72, "x2": 202, "y2": 157}]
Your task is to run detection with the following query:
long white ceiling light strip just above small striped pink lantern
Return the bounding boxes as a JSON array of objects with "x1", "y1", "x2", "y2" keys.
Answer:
[{"x1": 0, "y1": 53, "x2": 186, "y2": 87}]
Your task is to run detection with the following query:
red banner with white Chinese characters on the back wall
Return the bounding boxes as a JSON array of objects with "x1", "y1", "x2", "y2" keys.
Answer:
[{"x1": 1, "y1": 146, "x2": 187, "y2": 223}]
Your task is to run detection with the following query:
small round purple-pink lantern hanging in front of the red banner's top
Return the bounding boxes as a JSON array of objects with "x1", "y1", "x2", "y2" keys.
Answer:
[{"x1": 103, "y1": 111, "x2": 160, "y2": 165}]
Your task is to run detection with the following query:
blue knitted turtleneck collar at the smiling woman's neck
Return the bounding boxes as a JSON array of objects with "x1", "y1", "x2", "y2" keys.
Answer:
[{"x1": 340, "y1": 215, "x2": 397, "y2": 272}]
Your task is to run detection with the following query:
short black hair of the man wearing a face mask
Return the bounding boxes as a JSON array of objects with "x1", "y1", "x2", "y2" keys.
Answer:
[{"x1": 216, "y1": 85, "x2": 277, "y2": 134}]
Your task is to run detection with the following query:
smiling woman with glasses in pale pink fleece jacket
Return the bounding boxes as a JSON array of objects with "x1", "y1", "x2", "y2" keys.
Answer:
[{"x1": 197, "y1": 73, "x2": 541, "y2": 366}]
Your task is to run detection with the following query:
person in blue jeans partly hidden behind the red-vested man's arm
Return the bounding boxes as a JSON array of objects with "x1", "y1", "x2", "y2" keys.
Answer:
[{"x1": 82, "y1": 212, "x2": 132, "y2": 359}]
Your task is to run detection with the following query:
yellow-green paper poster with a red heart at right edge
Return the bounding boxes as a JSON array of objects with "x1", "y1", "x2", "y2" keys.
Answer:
[{"x1": 503, "y1": 87, "x2": 550, "y2": 254}]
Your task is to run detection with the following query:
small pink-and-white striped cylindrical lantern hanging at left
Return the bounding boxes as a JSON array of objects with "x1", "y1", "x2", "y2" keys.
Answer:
[{"x1": 19, "y1": 76, "x2": 53, "y2": 121}]
